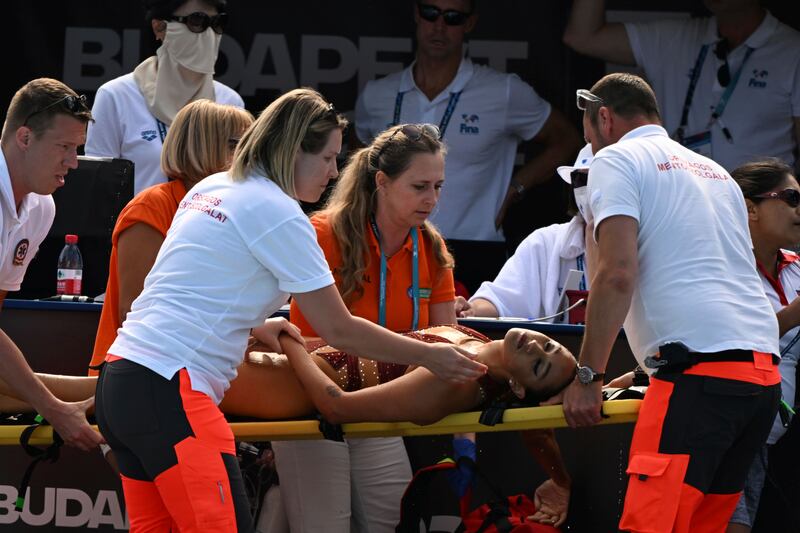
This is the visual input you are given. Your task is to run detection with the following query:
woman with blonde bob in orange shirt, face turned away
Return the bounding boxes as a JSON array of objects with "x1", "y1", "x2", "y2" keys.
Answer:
[{"x1": 89, "y1": 100, "x2": 253, "y2": 376}]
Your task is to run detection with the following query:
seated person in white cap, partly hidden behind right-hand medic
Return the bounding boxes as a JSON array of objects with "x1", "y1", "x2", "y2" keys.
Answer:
[{"x1": 455, "y1": 144, "x2": 592, "y2": 322}]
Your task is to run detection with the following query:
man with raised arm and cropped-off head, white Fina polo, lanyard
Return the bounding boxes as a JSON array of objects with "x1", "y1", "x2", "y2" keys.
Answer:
[{"x1": 564, "y1": 0, "x2": 800, "y2": 171}]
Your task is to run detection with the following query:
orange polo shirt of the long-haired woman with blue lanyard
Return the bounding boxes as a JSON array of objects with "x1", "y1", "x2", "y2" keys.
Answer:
[{"x1": 289, "y1": 215, "x2": 455, "y2": 337}]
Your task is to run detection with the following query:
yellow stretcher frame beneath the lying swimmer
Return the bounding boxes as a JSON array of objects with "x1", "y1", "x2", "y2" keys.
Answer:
[{"x1": 0, "y1": 400, "x2": 642, "y2": 446}]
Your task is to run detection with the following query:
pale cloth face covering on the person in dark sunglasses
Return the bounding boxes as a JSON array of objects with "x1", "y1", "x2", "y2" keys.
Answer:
[{"x1": 161, "y1": 22, "x2": 222, "y2": 74}]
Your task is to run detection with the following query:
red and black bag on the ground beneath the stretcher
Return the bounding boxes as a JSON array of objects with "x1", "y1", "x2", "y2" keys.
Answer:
[{"x1": 395, "y1": 457, "x2": 560, "y2": 533}]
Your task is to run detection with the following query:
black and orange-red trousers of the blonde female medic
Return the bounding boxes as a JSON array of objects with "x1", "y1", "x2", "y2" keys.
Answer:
[{"x1": 96, "y1": 359, "x2": 253, "y2": 533}]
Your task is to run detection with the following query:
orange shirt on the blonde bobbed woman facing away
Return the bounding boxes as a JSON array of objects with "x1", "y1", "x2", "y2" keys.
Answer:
[{"x1": 89, "y1": 180, "x2": 186, "y2": 376}]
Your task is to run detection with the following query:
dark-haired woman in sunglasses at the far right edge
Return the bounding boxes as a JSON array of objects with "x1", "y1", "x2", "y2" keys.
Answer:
[{"x1": 728, "y1": 158, "x2": 800, "y2": 533}]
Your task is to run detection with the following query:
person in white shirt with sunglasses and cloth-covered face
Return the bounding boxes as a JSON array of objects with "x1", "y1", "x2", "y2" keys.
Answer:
[{"x1": 85, "y1": 0, "x2": 244, "y2": 194}]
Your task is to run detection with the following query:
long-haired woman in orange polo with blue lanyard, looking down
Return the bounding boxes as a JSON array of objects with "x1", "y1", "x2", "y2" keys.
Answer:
[{"x1": 273, "y1": 124, "x2": 456, "y2": 532}]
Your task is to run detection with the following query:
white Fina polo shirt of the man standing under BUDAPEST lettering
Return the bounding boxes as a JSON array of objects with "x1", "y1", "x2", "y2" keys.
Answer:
[{"x1": 356, "y1": 58, "x2": 550, "y2": 241}]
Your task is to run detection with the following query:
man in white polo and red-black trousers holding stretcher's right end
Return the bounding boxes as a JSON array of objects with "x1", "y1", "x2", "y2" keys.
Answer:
[{"x1": 564, "y1": 74, "x2": 780, "y2": 532}]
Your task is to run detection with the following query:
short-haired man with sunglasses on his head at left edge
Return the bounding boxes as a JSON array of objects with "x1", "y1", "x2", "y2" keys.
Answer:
[{"x1": 0, "y1": 78, "x2": 103, "y2": 450}]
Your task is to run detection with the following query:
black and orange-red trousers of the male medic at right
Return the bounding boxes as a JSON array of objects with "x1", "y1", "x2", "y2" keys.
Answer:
[{"x1": 620, "y1": 362, "x2": 780, "y2": 533}]
